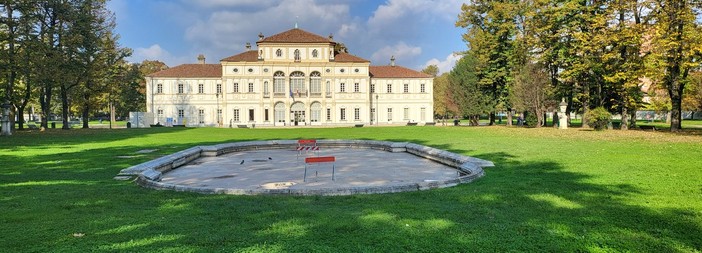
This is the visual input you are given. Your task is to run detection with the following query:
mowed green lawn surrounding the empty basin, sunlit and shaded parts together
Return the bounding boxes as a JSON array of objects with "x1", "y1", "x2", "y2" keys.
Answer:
[{"x1": 0, "y1": 126, "x2": 702, "y2": 252}]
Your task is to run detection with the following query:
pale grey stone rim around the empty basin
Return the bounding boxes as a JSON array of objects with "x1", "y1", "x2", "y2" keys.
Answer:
[{"x1": 118, "y1": 139, "x2": 494, "y2": 195}]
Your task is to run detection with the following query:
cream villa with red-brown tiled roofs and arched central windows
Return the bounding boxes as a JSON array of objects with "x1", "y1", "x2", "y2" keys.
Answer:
[{"x1": 146, "y1": 28, "x2": 434, "y2": 127}]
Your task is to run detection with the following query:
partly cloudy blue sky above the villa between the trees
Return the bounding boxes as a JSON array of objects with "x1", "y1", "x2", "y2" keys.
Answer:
[{"x1": 108, "y1": 0, "x2": 467, "y2": 72}]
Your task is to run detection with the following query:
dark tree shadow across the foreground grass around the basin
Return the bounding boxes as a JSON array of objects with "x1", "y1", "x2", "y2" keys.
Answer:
[{"x1": 0, "y1": 132, "x2": 702, "y2": 252}]
